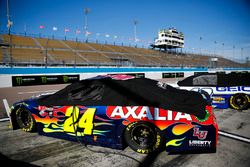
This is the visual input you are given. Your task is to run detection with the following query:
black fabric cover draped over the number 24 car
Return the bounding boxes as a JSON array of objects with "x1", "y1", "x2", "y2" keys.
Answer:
[{"x1": 38, "y1": 77, "x2": 207, "y2": 119}]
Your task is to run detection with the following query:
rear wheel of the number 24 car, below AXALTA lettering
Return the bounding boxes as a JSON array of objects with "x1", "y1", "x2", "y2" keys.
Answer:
[{"x1": 124, "y1": 121, "x2": 164, "y2": 154}]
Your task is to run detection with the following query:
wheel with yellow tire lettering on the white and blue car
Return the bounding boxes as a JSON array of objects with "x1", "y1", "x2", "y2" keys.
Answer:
[{"x1": 229, "y1": 93, "x2": 250, "y2": 110}]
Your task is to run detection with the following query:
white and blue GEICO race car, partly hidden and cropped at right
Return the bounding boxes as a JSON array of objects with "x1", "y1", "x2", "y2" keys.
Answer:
[{"x1": 170, "y1": 73, "x2": 250, "y2": 110}]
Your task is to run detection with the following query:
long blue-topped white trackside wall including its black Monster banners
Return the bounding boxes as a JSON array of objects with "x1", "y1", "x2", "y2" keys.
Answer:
[{"x1": 0, "y1": 67, "x2": 250, "y2": 88}]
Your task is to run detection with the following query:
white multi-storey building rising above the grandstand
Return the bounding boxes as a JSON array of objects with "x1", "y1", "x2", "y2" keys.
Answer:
[{"x1": 151, "y1": 28, "x2": 184, "y2": 50}]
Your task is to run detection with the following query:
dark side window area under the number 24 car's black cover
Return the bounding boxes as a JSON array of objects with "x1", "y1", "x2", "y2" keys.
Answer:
[{"x1": 68, "y1": 84, "x2": 104, "y2": 101}]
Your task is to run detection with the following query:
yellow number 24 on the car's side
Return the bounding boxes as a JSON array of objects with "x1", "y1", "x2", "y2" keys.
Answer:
[{"x1": 63, "y1": 106, "x2": 96, "y2": 135}]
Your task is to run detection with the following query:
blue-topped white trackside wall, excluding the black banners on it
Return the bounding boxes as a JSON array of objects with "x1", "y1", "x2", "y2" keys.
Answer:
[{"x1": 0, "y1": 67, "x2": 250, "y2": 88}]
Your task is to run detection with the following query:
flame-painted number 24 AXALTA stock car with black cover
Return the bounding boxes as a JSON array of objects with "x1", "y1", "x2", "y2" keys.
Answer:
[{"x1": 10, "y1": 75, "x2": 218, "y2": 154}]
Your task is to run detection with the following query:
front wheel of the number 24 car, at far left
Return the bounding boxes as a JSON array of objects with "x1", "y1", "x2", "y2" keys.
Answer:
[{"x1": 16, "y1": 107, "x2": 36, "y2": 132}]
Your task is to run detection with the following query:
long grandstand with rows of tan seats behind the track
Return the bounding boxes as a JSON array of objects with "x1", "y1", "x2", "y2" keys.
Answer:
[{"x1": 0, "y1": 34, "x2": 244, "y2": 67}]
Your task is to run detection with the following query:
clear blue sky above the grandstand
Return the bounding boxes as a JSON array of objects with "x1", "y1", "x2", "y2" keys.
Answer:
[{"x1": 0, "y1": 0, "x2": 250, "y2": 61}]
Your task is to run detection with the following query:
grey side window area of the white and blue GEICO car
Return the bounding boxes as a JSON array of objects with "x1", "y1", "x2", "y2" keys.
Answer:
[{"x1": 193, "y1": 75, "x2": 217, "y2": 86}]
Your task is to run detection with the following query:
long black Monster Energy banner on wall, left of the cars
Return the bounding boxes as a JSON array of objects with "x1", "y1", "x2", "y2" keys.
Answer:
[{"x1": 12, "y1": 75, "x2": 79, "y2": 86}]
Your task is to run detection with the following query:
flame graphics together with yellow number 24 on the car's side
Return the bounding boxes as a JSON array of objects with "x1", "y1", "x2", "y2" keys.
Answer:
[{"x1": 32, "y1": 106, "x2": 114, "y2": 136}]
